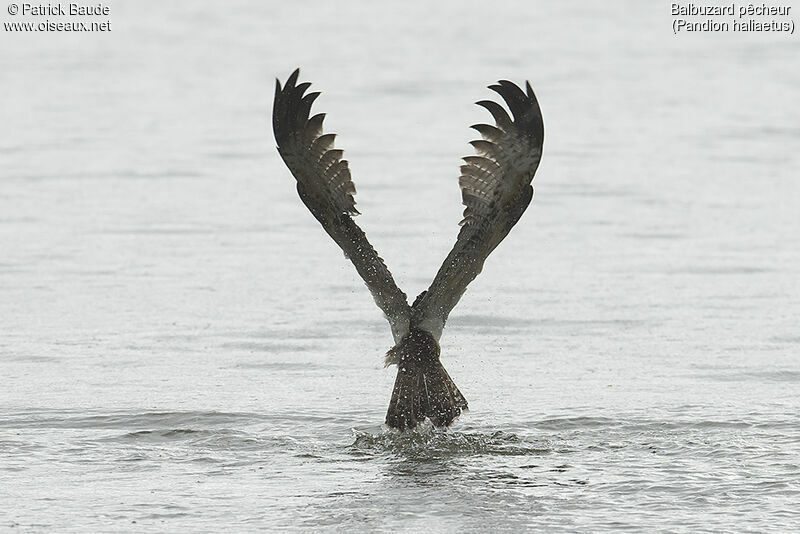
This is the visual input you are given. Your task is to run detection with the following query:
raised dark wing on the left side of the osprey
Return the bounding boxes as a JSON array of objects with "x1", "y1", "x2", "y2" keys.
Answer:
[{"x1": 272, "y1": 69, "x2": 411, "y2": 342}]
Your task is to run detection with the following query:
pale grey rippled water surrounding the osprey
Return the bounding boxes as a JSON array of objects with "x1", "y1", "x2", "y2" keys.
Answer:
[{"x1": 0, "y1": 2, "x2": 800, "y2": 532}]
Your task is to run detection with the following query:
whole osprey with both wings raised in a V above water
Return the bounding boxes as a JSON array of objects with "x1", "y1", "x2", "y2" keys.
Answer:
[{"x1": 272, "y1": 68, "x2": 544, "y2": 431}]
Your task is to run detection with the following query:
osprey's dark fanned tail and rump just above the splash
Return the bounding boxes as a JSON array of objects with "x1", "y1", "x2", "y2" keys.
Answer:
[{"x1": 386, "y1": 330, "x2": 468, "y2": 430}]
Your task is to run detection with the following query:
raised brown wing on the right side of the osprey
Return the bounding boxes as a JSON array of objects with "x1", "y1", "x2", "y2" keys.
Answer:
[{"x1": 412, "y1": 80, "x2": 544, "y2": 339}]
